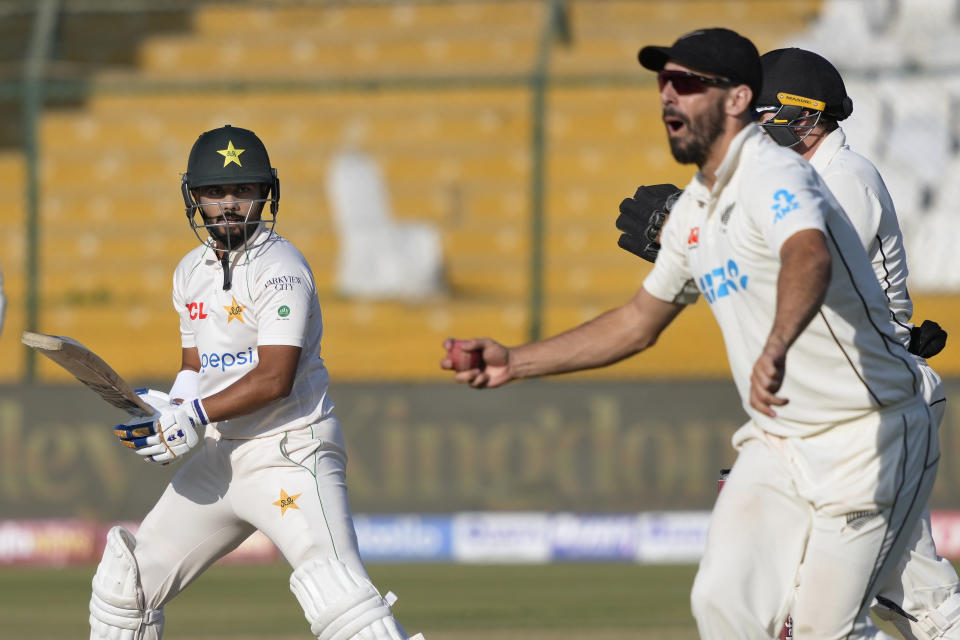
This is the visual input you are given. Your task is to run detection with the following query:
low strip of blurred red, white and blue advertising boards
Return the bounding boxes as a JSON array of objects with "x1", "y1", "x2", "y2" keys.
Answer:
[{"x1": 0, "y1": 511, "x2": 960, "y2": 567}]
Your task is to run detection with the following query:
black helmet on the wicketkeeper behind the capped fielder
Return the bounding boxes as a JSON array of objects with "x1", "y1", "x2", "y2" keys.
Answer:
[{"x1": 757, "y1": 47, "x2": 853, "y2": 120}]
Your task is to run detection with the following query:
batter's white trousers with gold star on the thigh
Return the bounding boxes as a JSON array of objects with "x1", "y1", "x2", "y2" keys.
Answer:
[{"x1": 135, "y1": 418, "x2": 369, "y2": 640}]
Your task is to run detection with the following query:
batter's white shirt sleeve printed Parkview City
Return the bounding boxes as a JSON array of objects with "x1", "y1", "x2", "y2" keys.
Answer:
[{"x1": 256, "y1": 255, "x2": 317, "y2": 347}]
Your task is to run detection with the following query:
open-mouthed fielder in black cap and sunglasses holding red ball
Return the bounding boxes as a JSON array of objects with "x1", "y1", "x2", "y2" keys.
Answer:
[{"x1": 441, "y1": 29, "x2": 939, "y2": 640}]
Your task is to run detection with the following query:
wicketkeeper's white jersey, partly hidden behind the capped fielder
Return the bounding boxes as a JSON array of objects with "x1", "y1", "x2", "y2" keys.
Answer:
[{"x1": 810, "y1": 129, "x2": 913, "y2": 345}]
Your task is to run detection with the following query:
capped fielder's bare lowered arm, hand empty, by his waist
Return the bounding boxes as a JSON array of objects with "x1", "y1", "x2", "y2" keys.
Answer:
[{"x1": 750, "y1": 229, "x2": 830, "y2": 417}]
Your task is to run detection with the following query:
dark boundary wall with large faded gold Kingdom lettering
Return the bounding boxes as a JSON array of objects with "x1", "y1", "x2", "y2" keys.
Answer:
[{"x1": 0, "y1": 378, "x2": 960, "y2": 522}]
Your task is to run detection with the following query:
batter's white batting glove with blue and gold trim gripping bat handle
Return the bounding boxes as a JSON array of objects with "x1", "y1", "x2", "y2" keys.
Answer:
[{"x1": 113, "y1": 398, "x2": 209, "y2": 465}]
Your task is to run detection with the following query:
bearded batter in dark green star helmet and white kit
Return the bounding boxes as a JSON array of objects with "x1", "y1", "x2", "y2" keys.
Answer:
[{"x1": 90, "y1": 125, "x2": 419, "y2": 640}]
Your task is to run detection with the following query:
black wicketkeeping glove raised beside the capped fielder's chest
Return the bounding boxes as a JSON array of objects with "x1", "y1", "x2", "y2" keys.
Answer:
[{"x1": 617, "y1": 184, "x2": 683, "y2": 262}]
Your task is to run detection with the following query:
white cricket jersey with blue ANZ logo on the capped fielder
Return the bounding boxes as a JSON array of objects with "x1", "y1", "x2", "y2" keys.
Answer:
[{"x1": 643, "y1": 125, "x2": 920, "y2": 436}]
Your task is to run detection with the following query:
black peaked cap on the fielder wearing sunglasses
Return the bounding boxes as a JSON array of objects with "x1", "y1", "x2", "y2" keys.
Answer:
[{"x1": 637, "y1": 27, "x2": 762, "y2": 99}]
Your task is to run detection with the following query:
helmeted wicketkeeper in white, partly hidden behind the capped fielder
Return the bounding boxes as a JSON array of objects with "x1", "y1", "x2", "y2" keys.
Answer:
[{"x1": 757, "y1": 48, "x2": 960, "y2": 640}]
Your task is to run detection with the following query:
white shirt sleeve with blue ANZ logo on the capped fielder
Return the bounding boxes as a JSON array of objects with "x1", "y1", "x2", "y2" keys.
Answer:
[{"x1": 740, "y1": 157, "x2": 838, "y2": 255}]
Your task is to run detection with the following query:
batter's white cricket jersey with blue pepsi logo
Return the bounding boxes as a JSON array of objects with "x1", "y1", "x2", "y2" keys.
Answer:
[{"x1": 173, "y1": 230, "x2": 333, "y2": 438}]
